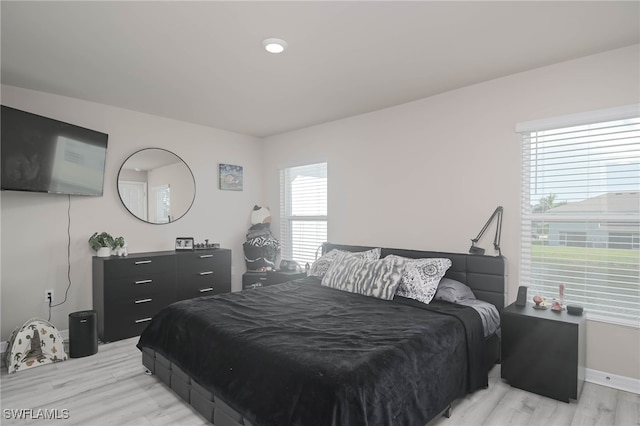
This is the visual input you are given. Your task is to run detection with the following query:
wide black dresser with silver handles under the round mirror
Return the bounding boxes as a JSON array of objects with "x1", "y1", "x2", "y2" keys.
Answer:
[{"x1": 93, "y1": 249, "x2": 231, "y2": 342}]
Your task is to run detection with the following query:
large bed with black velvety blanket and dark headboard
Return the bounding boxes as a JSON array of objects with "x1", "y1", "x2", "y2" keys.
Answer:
[{"x1": 138, "y1": 243, "x2": 507, "y2": 426}]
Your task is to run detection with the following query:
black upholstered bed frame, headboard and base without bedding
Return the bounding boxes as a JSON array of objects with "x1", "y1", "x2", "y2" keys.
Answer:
[{"x1": 142, "y1": 243, "x2": 507, "y2": 426}]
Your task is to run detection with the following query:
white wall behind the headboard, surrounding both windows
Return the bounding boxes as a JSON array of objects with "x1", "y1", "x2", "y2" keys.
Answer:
[{"x1": 263, "y1": 45, "x2": 640, "y2": 379}]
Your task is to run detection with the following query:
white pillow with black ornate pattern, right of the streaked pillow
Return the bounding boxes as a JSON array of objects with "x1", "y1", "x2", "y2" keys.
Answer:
[{"x1": 396, "y1": 258, "x2": 451, "y2": 303}]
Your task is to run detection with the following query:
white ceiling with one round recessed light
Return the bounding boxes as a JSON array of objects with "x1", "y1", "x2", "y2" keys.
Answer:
[{"x1": 1, "y1": 1, "x2": 640, "y2": 137}]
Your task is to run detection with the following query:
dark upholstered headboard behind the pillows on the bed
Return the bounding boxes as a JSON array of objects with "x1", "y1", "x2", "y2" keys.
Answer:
[{"x1": 322, "y1": 243, "x2": 507, "y2": 311}]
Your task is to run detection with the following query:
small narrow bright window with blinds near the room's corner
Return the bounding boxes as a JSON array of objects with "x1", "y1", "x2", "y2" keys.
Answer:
[{"x1": 280, "y1": 163, "x2": 327, "y2": 266}]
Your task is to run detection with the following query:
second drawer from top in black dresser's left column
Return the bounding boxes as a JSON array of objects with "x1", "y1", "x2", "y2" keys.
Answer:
[{"x1": 104, "y1": 274, "x2": 175, "y2": 302}]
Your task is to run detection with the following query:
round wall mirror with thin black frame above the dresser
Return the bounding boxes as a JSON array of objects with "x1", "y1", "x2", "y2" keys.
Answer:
[{"x1": 118, "y1": 148, "x2": 196, "y2": 224}]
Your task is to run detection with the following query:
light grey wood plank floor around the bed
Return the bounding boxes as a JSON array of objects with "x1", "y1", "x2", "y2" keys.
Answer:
[{"x1": 0, "y1": 338, "x2": 640, "y2": 426}]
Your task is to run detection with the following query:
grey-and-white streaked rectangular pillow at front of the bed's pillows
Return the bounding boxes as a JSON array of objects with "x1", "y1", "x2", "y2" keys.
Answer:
[{"x1": 322, "y1": 253, "x2": 407, "y2": 300}]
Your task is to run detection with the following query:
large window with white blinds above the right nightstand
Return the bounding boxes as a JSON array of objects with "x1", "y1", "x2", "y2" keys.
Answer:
[{"x1": 518, "y1": 105, "x2": 640, "y2": 324}]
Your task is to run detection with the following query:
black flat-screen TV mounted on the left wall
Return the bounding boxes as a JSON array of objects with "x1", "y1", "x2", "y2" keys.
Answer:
[{"x1": 0, "y1": 105, "x2": 109, "y2": 196}]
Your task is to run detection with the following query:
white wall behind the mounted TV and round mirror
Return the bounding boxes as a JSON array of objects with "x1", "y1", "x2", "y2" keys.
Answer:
[{"x1": 0, "y1": 86, "x2": 263, "y2": 340}]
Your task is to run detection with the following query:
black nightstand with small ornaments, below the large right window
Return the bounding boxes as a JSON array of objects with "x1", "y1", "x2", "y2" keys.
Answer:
[{"x1": 501, "y1": 303, "x2": 586, "y2": 402}]
